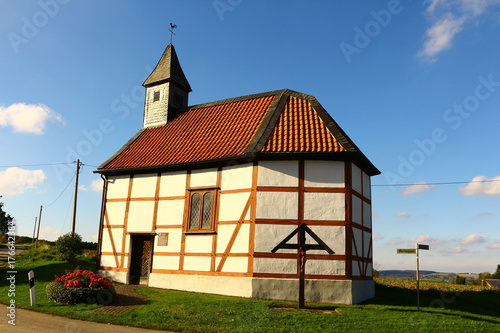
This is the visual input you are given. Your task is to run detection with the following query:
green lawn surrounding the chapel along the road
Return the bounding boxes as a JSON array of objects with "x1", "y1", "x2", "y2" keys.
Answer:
[{"x1": 0, "y1": 249, "x2": 500, "y2": 332}]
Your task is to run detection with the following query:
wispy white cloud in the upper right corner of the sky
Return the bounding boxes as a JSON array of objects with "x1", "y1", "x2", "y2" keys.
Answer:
[{"x1": 418, "y1": 0, "x2": 500, "y2": 62}]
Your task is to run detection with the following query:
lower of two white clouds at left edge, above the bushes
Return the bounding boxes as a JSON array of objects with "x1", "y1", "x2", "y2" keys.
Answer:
[{"x1": 0, "y1": 167, "x2": 46, "y2": 195}]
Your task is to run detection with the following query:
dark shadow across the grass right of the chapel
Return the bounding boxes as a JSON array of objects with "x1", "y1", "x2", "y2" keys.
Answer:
[{"x1": 371, "y1": 283, "x2": 500, "y2": 320}]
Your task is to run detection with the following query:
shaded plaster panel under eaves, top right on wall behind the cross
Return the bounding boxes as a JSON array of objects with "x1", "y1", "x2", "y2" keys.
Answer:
[{"x1": 304, "y1": 161, "x2": 345, "y2": 187}]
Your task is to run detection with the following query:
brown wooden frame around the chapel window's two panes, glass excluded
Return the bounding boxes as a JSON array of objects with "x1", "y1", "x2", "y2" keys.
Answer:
[{"x1": 184, "y1": 187, "x2": 219, "y2": 234}]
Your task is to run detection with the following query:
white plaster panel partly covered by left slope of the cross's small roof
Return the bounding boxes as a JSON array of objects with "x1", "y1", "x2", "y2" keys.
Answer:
[{"x1": 254, "y1": 224, "x2": 297, "y2": 253}]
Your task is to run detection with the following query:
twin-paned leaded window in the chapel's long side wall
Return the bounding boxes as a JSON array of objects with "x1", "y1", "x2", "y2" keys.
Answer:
[{"x1": 186, "y1": 189, "x2": 217, "y2": 232}]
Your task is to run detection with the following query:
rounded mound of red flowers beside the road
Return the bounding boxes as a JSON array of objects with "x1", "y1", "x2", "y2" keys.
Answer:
[{"x1": 45, "y1": 270, "x2": 116, "y2": 305}]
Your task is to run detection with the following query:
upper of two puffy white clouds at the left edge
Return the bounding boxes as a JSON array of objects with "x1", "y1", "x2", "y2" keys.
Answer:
[{"x1": 0, "y1": 103, "x2": 64, "y2": 134}]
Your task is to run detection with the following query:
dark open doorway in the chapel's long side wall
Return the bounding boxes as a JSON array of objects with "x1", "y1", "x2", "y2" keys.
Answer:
[{"x1": 129, "y1": 235, "x2": 154, "y2": 285}]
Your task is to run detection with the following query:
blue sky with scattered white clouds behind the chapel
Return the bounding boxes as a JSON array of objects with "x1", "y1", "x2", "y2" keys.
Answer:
[{"x1": 0, "y1": 0, "x2": 500, "y2": 272}]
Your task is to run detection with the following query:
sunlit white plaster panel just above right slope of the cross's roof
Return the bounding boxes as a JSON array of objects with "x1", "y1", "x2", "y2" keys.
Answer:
[{"x1": 304, "y1": 192, "x2": 345, "y2": 221}]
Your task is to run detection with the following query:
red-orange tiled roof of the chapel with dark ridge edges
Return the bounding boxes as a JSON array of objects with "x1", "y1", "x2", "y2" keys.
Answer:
[{"x1": 97, "y1": 90, "x2": 380, "y2": 174}]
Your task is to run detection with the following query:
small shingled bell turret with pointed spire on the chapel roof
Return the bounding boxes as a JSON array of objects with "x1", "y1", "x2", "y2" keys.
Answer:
[{"x1": 142, "y1": 44, "x2": 191, "y2": 127}]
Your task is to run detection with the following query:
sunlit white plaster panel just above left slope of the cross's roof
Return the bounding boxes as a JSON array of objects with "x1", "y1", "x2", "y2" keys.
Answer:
[{"x1": 256, "y1": 192, "x2": 299, "y2": 220}]
